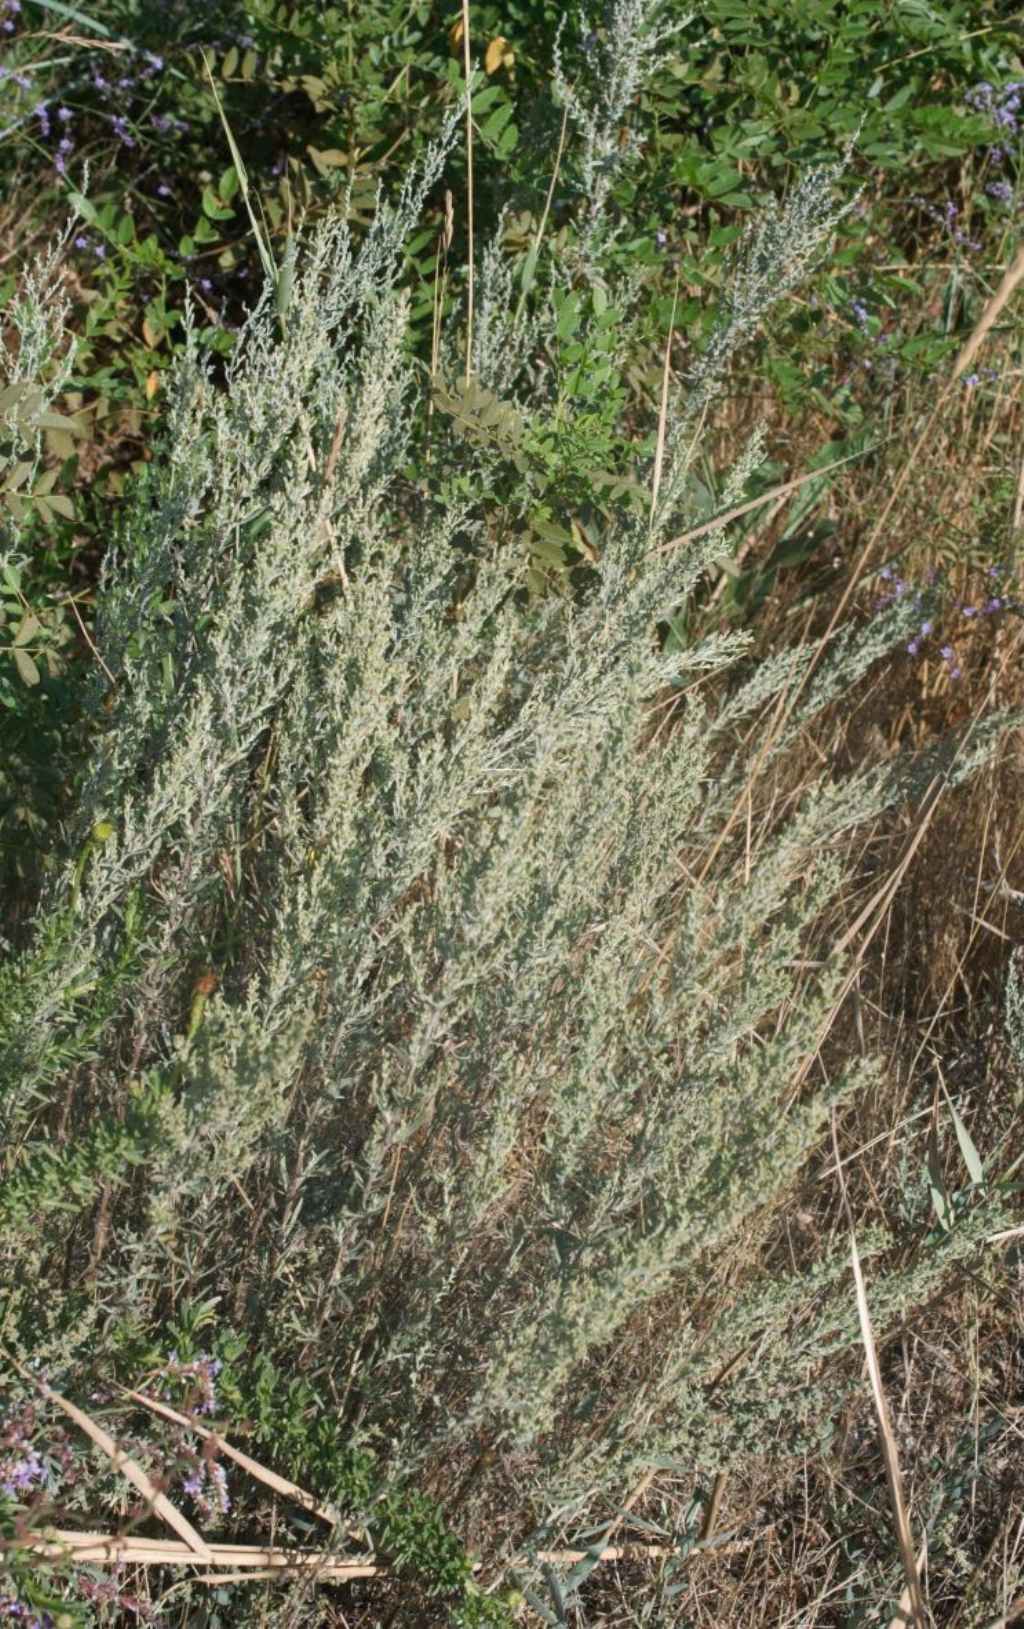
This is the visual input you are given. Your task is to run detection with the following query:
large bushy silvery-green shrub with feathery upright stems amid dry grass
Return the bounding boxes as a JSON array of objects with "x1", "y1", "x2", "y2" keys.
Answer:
[{"x1": 0, "y1": 6, "x2": 1017, "y2": 1609}]
